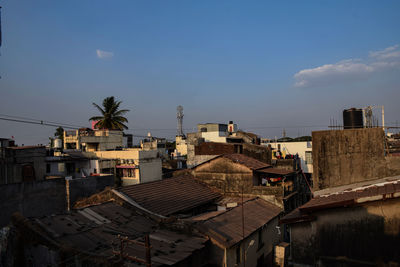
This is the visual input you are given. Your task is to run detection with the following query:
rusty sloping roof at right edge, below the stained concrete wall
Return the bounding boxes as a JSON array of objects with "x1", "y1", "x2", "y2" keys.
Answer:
[{"x1": 281, "y1": 176, "x2": 400, "y2": 223}]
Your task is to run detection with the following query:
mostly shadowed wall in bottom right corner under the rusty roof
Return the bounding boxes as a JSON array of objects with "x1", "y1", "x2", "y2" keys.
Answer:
[{"x1": 290, "y1": 198, "x2": 400, "y2": 266}]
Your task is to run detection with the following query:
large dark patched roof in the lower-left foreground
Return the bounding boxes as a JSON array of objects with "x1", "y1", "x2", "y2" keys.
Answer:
[{"x1": 17, "y1": 202, "x2": 206, "y2": 266}]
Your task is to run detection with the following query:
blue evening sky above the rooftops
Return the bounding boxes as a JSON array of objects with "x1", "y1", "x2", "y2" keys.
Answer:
[{"x1": 0, "y1": 0, "x2": 400, "y2": 145}]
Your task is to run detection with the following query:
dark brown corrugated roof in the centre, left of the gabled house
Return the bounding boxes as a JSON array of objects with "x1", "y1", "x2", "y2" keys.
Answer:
[{"x1": 119, "y1": 176, "x2": 221, "y2": 216}]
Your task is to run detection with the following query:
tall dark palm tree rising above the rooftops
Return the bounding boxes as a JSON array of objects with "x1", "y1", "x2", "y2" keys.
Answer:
[{"x1": 89, "y1": 96, "x2": 129, "y2": 130}]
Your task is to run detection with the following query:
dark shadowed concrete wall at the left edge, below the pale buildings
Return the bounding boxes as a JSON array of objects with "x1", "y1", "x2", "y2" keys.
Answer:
[{"x1": 0, "y1": 176, "x2": 114, "y2": 227}]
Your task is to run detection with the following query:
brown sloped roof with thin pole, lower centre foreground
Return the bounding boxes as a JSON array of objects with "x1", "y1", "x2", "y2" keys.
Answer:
[{"x1": 196, "y1": 198, "x2": 281, "y2": 248}]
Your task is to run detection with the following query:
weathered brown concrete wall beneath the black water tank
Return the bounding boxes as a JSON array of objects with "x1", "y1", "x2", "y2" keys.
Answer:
[{"x1": 312, "y1": 128, "x2": 400, "y2": 190}]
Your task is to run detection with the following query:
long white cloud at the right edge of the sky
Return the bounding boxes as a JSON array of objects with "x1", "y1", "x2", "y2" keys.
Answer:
[{"x1": 294, "y1": 45, "x2": 400, "y2": 87}]
